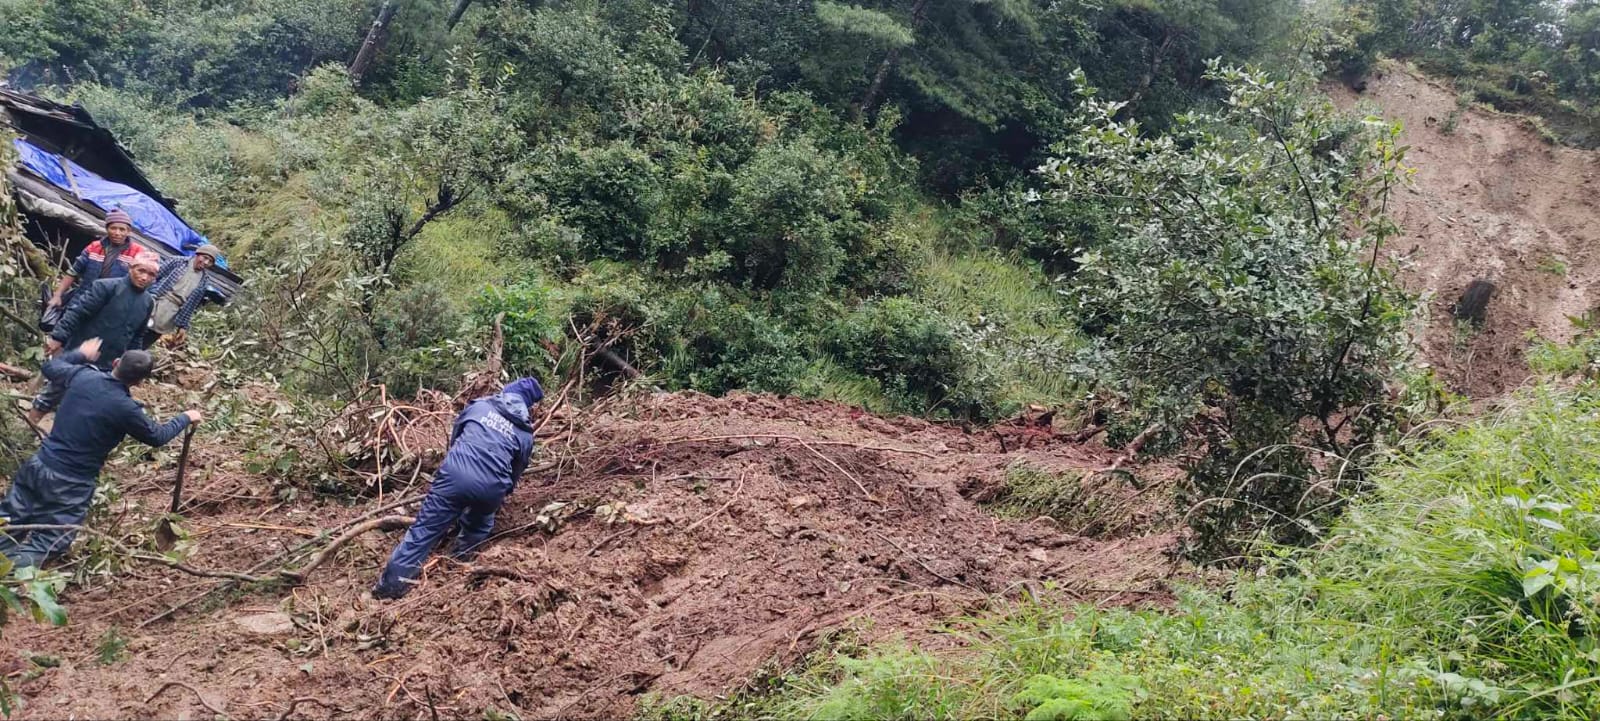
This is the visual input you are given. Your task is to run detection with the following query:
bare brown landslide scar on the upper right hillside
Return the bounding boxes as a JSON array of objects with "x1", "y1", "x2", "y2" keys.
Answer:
[{"x1": 1334, "y1": 64, "x2": 1600, "y2": 398}]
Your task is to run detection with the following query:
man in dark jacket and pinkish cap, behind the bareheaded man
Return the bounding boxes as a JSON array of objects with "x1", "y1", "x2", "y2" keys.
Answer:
[{"x1": 27, "y1": 253, "x2": 158, "y2": 424}]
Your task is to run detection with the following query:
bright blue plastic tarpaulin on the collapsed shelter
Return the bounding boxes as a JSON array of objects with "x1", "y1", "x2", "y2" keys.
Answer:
[{"x1": 13, "y1": 139, "x2": 227, "y2": 269}]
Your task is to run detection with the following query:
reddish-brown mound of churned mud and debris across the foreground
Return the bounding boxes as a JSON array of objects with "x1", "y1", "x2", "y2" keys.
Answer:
[{"x1": 0, "y1": 393, "x2": 1173, "y2": 719}]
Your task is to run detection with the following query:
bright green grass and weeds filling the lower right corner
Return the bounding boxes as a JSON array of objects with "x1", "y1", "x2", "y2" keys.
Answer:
[{"x1": 656, "y1": 385, "x2": 1600, "y2": 719}]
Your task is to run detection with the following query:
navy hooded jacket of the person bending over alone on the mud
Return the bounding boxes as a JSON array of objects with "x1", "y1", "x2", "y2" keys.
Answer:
[{"x1": 434, "y1": 395, "x2": 533, "y2": 492}]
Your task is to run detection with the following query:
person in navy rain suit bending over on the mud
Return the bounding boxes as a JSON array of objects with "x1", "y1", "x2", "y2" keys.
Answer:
[{"x1": 373, "y1": 377, "x2": 544, "y2": 598}]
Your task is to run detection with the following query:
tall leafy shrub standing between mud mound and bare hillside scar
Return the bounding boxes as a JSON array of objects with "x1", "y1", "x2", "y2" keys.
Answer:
[{"x1": 1045, "y1": 66, "x2": 1411, "y2": 560}]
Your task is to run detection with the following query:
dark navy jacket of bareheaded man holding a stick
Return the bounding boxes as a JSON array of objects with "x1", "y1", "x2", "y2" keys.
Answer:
[{"x1": 38, "y1": 350, "x2": 189, "y2": 480}]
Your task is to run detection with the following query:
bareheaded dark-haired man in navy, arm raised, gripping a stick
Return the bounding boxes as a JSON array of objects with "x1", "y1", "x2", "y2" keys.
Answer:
[{"x1": 0, "y1": 337, "x2": 203, "y2": 568}]
